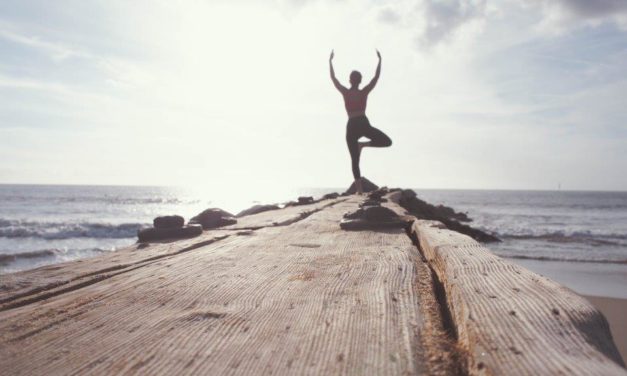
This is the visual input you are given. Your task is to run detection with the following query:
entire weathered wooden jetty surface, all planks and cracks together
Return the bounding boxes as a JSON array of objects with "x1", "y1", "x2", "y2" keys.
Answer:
[{"x1": 0, "y1": 191, "x2": 627, "y2": 375}]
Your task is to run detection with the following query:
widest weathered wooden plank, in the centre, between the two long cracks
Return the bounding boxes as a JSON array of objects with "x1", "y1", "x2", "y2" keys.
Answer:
[{"x1": 0, "y1": 199, "x2": 444, "y2": 375}]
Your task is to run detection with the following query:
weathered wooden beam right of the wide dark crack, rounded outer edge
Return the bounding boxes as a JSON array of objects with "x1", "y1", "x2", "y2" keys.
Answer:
[{"x1": 412, "y1": 221, "x2": 627, "y2": 375}]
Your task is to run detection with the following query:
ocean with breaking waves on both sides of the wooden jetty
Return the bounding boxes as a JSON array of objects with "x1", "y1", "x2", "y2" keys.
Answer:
[{"x1": 0, "y1": 185, "x2": 627, "y2": 294}]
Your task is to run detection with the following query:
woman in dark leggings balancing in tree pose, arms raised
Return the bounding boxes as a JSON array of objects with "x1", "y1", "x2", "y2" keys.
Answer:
[{"x1": 329, "y1": 50, "x2": 392, "y2": 194}]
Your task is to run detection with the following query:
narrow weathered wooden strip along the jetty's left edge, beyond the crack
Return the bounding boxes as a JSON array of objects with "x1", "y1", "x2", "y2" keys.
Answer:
[{"x1": 0, "y1": 198, "x2": 346, "y2": 310}]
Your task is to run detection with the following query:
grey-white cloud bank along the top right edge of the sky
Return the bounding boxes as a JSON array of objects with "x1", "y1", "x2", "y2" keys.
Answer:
[{"x1": 377, "y1": 0, "x2": 627, "y2": 49}]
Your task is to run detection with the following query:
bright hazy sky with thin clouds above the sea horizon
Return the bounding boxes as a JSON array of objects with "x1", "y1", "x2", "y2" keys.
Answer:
[{"x1": 0, "y1": 0, "x2": 627, "y2": 190}]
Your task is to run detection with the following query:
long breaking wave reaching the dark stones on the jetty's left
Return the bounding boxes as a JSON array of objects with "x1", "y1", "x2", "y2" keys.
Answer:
[{"x1": 0, "y1": 219, "x2": 146, "y2": 240}]
